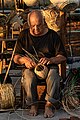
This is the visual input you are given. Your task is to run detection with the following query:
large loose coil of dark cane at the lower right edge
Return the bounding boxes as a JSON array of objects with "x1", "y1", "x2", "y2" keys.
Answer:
[{"x1": 62, "y1": 78, "x2": 80, "y2": 117}]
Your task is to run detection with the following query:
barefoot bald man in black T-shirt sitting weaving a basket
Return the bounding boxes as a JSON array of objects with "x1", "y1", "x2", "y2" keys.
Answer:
[{"x1": 14, "y1": 10, "x2": 66, "y2": 118}]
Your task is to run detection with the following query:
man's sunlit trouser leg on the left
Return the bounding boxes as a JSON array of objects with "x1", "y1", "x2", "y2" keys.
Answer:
[{"x1": 22, "y1": 69, "x2": 38, "y2": 103}]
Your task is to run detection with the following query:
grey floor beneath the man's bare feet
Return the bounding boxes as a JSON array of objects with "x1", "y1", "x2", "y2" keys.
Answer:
[{"x1": 0, "y1": 109, "x2": 70, "y2": 120}]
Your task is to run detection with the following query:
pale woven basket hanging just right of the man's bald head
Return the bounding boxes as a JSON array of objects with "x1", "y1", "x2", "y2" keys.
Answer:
[{"x1": 42, "y1": 7, "x2": 60, "y2": 32}]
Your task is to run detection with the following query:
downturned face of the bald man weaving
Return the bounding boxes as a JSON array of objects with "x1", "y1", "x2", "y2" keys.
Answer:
[{"x1": 30, "y1": 17, "x2": 44, "y2": 36}]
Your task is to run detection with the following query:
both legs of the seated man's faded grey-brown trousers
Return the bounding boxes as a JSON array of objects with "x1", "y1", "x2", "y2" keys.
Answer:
[{"x1": 22, "y1": 68, "x2": 61, "y2": 104}]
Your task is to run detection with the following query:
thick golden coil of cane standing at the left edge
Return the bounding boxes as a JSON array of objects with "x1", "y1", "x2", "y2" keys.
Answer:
[{"x1": 0, "y1": 83, "x2": 15, "y2": 109}]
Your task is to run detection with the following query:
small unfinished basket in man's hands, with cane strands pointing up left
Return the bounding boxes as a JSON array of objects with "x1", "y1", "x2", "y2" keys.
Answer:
[{"x1": 22, "y1": 48, "x2": 48, "y2": 79}]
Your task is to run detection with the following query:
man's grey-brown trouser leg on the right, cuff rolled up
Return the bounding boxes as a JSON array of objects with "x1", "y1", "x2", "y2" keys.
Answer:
[{"x1": 45, "y1": 69, "x2": 60, "y2": 103}]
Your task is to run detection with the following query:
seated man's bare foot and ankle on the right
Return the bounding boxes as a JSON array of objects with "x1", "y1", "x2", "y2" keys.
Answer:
[{"x1": 44, "y1": 102, "x2": 54, "y2": 118}]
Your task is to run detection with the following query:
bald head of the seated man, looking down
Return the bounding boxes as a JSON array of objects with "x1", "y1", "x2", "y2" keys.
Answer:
[{"x1": 28, "y1": 10, "x2": 46, "y2": 36}]
